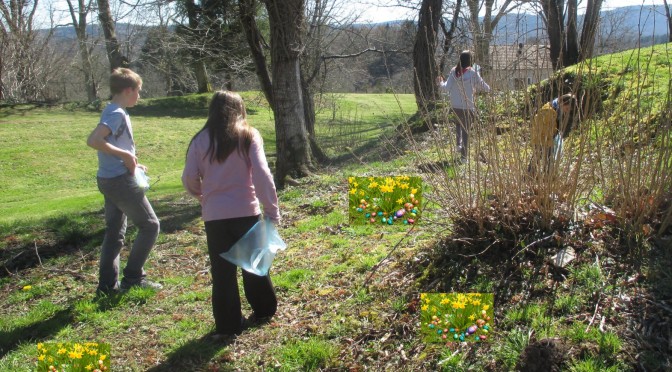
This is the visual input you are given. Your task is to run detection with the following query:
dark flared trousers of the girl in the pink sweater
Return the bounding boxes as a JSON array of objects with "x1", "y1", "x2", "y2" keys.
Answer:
[{"x1": 205, "y1": 216, "x2": 278, "y2": 334}]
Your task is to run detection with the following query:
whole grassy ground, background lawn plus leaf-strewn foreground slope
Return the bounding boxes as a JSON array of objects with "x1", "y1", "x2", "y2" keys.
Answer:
[{"x1": 0, "y1": 45, "x2": 672, "y2": 371}]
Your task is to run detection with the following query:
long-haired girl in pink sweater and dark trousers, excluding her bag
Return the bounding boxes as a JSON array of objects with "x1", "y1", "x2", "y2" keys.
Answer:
[{"x1": 182, "y1": 91, "x2": 280, "y2": 338}]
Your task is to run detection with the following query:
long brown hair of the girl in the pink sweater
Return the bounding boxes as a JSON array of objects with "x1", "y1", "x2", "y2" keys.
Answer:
[{"x1": 189, "y1": 90, "x2": 253, "y2": 163}]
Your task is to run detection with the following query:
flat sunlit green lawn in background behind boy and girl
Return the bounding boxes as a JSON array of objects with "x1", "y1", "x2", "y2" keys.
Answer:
[{"x1": 0, "y1": 92, "x2": 415, "y2": 227}]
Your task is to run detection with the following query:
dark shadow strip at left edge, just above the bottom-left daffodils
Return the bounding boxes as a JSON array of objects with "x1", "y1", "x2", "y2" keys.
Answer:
[{"x1": 0, "y1": 308, "x2": 74, "y2": 359}]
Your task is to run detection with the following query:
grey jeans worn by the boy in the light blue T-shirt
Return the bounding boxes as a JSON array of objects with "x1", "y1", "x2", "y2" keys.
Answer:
[{"x1": 98, "y1": 173, "x2": 159, "y2": 290}]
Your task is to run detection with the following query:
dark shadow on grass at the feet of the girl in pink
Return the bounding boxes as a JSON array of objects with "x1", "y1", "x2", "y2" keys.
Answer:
[{"x1": 147, "y1": 335, "x2": 234, "y2": 372}]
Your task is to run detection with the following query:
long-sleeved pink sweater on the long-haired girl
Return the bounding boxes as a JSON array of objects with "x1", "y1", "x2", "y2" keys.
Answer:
[{"x1": 182, "y1": 129, "x2": 280, "y2": 222}]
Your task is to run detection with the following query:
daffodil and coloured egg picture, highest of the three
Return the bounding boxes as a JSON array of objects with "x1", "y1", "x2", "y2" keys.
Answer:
[{"x1": 348, "y1": 176, "x2": 422, "y2": 225}]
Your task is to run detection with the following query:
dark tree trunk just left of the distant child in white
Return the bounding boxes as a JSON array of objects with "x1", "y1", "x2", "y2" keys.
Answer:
[{"x1": 413, "y1": 0, "x2": 443, "y2": 114}]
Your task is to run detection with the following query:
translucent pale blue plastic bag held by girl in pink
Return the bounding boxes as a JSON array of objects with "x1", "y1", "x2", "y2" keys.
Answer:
[{"x1": 220, "y1": 218, "x2": 287, "y2": 276}]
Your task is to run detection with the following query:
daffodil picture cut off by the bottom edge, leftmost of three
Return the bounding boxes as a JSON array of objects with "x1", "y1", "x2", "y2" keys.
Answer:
[{"x1": 36, "y1": 342, "x2": 110, "y2": 372}]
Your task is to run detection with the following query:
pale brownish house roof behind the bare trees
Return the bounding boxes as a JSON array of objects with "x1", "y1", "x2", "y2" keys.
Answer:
[{"x1": 490, "y1": 43, "x2": 553, "y2": 70}]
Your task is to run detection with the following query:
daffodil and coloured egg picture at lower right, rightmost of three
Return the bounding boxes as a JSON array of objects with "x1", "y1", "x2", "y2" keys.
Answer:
[{"x1": 420, "y1": 293, "x2": 494, "y2": 343}]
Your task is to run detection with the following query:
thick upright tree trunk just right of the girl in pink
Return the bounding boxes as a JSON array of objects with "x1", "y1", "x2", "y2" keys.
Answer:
[{"x1": 265, "y1": 0, "x2": 312, "y2": 188}]
